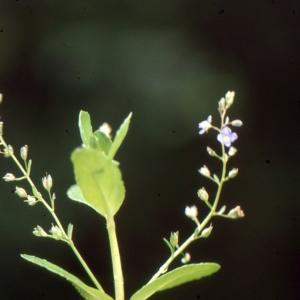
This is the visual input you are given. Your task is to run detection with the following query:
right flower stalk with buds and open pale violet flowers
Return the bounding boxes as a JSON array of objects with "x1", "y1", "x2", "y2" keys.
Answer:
[{"x1": 147, "y1": 92, "x2": 244, "y2": 284}]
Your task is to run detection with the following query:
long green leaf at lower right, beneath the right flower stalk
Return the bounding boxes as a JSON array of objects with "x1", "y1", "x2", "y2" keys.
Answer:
[{"x1": 130, "y1": 263, "x2": 220, "y2": 300}]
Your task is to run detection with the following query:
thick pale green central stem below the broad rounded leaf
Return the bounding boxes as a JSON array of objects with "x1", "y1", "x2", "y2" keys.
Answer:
[{"x1": 106, "y1": 216, "x2": 124, "y2": 300}]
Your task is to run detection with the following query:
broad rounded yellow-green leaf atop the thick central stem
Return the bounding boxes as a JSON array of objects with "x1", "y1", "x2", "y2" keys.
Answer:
[{"x1": 71, "y1": 148, "x2": 125, "y2": 218}]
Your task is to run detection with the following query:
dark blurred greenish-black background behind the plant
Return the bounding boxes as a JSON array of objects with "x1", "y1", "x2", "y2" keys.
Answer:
[{"x1": 0, "y1": 0, "x2": 300, "y2": 300}]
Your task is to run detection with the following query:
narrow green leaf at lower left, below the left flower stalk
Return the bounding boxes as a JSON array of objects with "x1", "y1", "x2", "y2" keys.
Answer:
[{"x1": 21, "y1": 254, "x2": 113, "y2": 300}]
